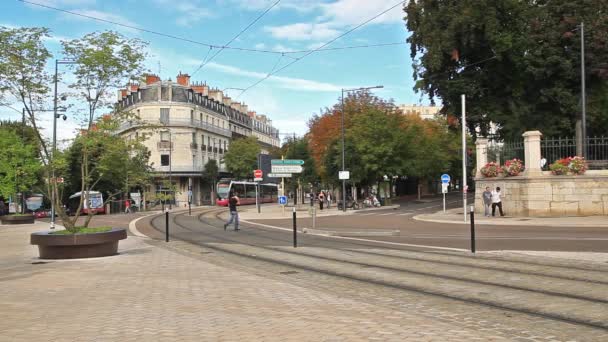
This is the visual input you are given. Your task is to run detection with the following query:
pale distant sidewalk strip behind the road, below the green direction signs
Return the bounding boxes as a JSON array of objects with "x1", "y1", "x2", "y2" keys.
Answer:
[{"x1": 238, "y1": 203, "x2": 399, "y2": 220}]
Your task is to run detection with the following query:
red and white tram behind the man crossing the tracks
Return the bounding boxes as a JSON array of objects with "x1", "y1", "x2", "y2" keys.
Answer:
[{"x1": 215, "y1": 179, "x2": 279, "y2": 207}]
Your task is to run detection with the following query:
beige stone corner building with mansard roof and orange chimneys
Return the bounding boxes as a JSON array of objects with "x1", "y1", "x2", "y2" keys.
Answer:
[{"x1": 117, "y1": 73, "x2": 280, "y2": 206}]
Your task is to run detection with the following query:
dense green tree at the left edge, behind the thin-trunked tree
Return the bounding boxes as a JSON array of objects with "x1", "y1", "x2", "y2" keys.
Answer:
[{"x1": 0, "y1": 127, "x2": 42, "y2": 202}]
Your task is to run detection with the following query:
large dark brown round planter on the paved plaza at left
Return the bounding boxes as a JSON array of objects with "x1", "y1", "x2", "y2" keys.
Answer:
[{"x1": 30, "y1": 228, "x2": 127, "y2": 259}]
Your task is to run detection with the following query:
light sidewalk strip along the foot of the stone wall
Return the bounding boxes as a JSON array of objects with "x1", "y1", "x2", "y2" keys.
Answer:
[{"x1": 413, "y1": 208, "x2": 608, "y2": 228}]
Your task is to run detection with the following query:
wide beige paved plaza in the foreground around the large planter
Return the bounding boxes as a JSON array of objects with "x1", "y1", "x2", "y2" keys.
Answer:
[{"x1": 0, "y1": 218, "x2": 508, "y2": 342}]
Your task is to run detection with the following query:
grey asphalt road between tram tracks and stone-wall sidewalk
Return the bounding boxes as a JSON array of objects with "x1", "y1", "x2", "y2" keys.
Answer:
[{"x1": 252, "y1": 194, "x2": 608, "y2": 252}]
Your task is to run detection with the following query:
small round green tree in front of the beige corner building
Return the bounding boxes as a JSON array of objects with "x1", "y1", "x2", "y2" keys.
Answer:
[{"x1": 224, "y1": 136, "x2": 261, "y2": 179}]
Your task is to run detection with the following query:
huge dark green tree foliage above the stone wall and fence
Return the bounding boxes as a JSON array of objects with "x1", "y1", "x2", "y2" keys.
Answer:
[{"x1": 405, "y1": 0, "x2": 608, "y2": 139}]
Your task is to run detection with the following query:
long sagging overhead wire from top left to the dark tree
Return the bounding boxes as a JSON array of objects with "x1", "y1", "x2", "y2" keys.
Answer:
[{"x1": 17, "y1": 0, "x2": 407, "y2": 59}]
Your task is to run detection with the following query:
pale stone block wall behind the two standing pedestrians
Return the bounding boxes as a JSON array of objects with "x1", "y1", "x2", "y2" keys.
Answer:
[{"x1": 475, "y1": 171, "x2": 608, "y2": 217}]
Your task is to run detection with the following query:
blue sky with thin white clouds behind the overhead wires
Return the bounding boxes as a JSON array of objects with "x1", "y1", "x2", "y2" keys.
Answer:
[{"x1": 0, "y1": 0, "x2": 428, "y2": 140}]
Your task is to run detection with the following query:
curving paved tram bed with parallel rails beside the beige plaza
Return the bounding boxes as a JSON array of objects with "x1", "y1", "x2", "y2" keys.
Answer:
[{"x1": 134, "y1": 210, "x2": 608, "y2": 341}]
